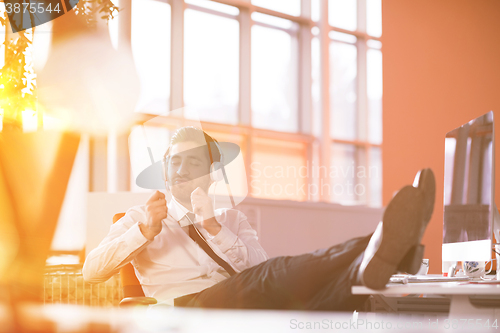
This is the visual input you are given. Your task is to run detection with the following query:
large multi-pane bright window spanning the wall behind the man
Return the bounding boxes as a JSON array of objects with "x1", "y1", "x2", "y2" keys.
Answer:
[{"x1": 121, "y1": 0, "x2": 382, "y2": 206}]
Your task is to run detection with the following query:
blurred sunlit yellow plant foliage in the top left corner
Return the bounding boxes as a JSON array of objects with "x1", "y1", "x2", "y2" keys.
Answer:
[{"x1": 0, "y1": 0, "x2": 119, "y2": 130}]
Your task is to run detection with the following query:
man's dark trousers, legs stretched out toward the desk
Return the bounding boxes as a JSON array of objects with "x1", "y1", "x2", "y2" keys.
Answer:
[{"x1": 175, "y1": 235, "x2": 371, "y2": 311}]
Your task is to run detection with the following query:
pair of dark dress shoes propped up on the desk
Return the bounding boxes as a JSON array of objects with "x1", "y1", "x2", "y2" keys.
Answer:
[{"x1": 358, "y1": 169, "x2": 436, "y2": 289}]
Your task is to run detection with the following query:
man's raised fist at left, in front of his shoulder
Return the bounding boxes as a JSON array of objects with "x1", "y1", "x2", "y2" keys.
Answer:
[{"x1": 139, "y1": 191, "x2": 168, "y2": 240}]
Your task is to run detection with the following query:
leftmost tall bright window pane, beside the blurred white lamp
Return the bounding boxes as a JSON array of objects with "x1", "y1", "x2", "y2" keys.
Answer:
[{"x1": 132, "y1": 0, "x2": 170, "y2": 114}]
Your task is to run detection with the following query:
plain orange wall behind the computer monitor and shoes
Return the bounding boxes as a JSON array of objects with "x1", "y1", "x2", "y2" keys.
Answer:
[{"x1": 382, "y1": 0, "x2": 500, "y2": 273}]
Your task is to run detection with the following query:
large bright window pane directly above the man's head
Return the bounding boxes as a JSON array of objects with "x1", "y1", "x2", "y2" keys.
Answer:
[{"x1": 184, "y1": 9, "x2": 239, "y2": 124}]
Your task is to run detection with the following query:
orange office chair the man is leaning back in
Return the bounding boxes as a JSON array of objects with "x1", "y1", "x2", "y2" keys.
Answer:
[{"x1": 113, "y1": 213, "x2": 157, "y2": 307}]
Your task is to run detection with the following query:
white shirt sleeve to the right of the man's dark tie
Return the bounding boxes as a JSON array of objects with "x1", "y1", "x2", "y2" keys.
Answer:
[{"x1": 210, "y1": 210, "x2": 269, "y2": 272}]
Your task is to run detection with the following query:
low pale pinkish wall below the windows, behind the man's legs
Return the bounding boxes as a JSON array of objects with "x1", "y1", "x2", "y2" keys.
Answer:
[{"x1": 238, "y1": 198, "x2": 382, "y2": 257}]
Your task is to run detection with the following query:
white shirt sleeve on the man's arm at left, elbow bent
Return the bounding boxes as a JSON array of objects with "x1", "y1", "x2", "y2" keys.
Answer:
[{"x1": 82, "y1": 207, "x2": 151, "y2": 283}]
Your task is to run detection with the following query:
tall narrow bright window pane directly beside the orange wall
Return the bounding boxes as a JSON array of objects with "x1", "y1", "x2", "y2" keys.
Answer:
[{"x1": 366, "y1": 50, "x2": 382, "y2": 144}]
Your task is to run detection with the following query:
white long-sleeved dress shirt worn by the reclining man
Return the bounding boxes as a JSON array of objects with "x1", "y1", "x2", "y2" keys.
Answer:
[{"x1": 83, "y1": 199, "x2": 269, "y2": 305}]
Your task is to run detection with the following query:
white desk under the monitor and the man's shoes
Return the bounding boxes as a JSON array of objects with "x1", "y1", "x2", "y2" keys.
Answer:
[{"x1": 352, "y1": 282, "x2": 500, "y2": 319}]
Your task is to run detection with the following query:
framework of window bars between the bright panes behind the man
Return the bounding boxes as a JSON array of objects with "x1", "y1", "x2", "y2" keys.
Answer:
[{"x1": 105, "y1": 0, "x2": 382, "y2": 204}]
